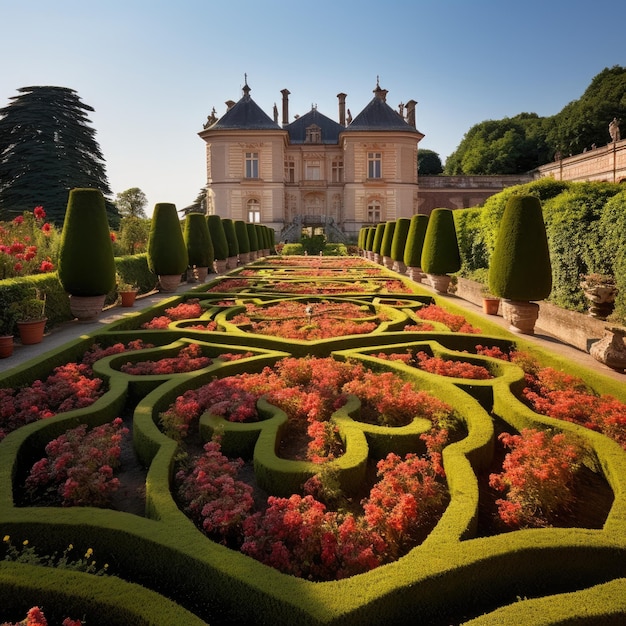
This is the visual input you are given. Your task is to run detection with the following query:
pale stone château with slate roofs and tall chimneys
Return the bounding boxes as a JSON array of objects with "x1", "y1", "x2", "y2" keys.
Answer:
[{"x1": 199, "y1": 84, "x2": 424, "y2": 241}]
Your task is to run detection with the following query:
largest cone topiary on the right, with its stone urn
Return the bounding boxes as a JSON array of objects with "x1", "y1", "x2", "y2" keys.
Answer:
[{"x1": 489, "y1": 196, "x2": 552, "y2": 334}]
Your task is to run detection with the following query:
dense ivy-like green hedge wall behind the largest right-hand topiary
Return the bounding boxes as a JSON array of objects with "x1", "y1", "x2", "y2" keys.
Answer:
[{"x1": 454, "y1": 178, "x2": 626, "y2": 324}]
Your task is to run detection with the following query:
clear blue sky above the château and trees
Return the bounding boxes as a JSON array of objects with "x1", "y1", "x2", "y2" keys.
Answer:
[{"x1": 0, "y1": 0, "x2": 626, "y2": 214}]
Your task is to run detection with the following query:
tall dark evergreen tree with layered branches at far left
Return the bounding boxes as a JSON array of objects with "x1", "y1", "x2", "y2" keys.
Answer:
[{"x1": 0, "y1": 87, "x2": 119, "y2": 227}]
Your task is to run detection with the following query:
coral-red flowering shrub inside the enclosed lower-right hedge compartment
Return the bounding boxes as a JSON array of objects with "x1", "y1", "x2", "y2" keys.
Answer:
[{"x1": 489, "y1": 429, "x2": 582, "y2": 528}]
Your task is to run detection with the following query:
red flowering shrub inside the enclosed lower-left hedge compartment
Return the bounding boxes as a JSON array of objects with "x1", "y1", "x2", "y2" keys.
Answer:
[{"x1": 25, "y1": 417, "x2": 128, "y2": 507}]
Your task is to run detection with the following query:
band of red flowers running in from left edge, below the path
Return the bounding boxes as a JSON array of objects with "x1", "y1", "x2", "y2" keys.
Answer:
[{"x1": 0, "y1": 340, "x2": 149, "y2": 441}]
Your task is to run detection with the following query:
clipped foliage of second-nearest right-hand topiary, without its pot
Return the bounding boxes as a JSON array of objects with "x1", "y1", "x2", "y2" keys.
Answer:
[{"x1": 421, "y1": 209, "x2": 461, "y2": 276}]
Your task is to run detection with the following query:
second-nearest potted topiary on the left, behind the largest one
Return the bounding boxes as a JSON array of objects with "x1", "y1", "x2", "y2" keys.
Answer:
[{"x1": 148, "y1": 202, "x2": 189, "y2": 292}]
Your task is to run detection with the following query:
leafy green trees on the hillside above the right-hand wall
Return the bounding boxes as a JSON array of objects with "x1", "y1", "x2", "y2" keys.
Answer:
[{"x1": 444, "y1": 65, "x2": 626, "y2": 175}]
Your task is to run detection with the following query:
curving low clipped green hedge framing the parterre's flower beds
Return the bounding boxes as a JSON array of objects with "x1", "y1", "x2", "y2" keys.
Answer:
[{"x1": 0, "y1": 256, "x2": 626, "y2": 624}]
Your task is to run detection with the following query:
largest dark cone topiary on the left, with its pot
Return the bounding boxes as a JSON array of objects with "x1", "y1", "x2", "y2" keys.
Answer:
[{"x1": 58, "y1": 189, "x2": 115, "y2": 321}]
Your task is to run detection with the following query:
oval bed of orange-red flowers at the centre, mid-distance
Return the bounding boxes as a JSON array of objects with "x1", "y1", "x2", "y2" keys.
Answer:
[{"x1": 231, "y1": 301, "x2": 386, "y2": 341}]
